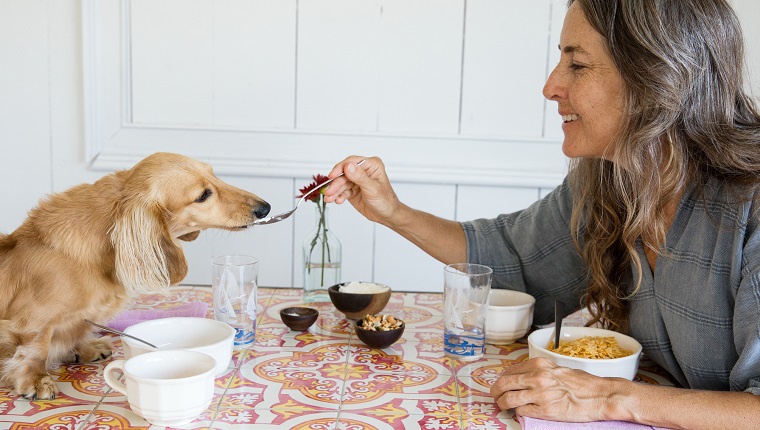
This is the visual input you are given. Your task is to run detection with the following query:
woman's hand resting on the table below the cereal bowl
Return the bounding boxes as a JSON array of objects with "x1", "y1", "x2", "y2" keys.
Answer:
[{"x1": 491, "y1": 358, "x2": 630, "y2": 422}]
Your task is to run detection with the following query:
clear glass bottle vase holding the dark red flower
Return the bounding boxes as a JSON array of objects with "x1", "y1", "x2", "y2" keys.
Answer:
[{"x1": 303, "y1": 202, "x2": 341, "y2": 302}]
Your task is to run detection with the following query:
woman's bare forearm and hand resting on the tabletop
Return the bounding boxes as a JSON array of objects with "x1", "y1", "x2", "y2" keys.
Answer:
[{"x1": 491, "y1": 358, "x2": 760, "y2": 430}]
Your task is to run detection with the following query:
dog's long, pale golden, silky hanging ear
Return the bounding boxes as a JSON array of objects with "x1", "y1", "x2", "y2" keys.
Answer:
[{"x1": 111, "y1": 199, "x2": 187, "y2": 295}]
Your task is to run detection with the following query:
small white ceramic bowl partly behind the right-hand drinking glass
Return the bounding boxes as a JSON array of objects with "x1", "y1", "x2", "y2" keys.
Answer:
[{"x1": 486, "y1": 289, "x2": 536, "y2": 345}]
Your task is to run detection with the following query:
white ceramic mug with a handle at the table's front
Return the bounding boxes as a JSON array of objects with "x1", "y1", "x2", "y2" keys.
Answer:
[{"x1": 103, "y1": 350, "x2": 216, "y2": 427}]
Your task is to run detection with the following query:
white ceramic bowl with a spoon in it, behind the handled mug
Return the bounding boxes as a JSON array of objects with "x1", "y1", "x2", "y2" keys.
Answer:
[{"x1": 121, "y1": 317, "x2": 235, "y2": 375}]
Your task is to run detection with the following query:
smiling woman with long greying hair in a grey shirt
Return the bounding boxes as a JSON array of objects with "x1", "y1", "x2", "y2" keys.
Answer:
[{"x1": 325, "y1": 0, "x2": 760, "y2": 429}]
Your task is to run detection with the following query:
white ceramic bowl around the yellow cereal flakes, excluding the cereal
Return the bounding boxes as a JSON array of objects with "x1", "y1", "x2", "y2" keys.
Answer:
[{"x1": 528, "y1": 327, "x2": 641, "y2": 380}]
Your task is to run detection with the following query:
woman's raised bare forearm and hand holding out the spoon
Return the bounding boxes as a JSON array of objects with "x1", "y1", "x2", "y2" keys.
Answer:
[{"x1": 325, "y1": 156, "x2": 467, "y2": 264}]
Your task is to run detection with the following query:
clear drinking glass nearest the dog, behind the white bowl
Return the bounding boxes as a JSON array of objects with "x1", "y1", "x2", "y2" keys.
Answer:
[{"x1": 211, "y1": 255, "x2": 259, "y2": 349}]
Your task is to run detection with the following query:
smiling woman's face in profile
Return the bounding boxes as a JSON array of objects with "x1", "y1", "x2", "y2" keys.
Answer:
[{"x1": 544, "y1": 3, "x2": 624, "y2": 159}]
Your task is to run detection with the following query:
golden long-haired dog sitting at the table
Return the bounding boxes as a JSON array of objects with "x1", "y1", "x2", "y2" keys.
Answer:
[{"x1": 0, "y1": 153, "x2": 269, "y2": 399}]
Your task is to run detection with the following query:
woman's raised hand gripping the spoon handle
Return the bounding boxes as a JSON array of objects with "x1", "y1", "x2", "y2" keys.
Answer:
[{"x1": 324, "y1": 155, "x2": 402, "y2": 226}]
